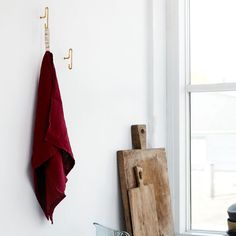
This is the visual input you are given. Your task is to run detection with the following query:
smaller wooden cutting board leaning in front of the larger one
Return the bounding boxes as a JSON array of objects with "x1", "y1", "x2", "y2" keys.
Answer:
[{"x1": 128, "y1": 166, "x2": 159, "y2": 236}]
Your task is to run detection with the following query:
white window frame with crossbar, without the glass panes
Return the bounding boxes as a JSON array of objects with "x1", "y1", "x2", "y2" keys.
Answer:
[{"x1": 164, "y1": 0, "x2": 236, "y2": 236}]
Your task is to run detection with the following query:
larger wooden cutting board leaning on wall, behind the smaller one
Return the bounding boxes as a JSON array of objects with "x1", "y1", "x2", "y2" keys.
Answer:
[{"x1": 117, "y1": 125, "x2": 174, "y2": 236}]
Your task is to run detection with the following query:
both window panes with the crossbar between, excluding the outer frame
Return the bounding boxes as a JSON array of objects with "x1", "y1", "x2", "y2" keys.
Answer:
[{"x1": 190, "y1": 0, "x2": 236, "y2": 231}]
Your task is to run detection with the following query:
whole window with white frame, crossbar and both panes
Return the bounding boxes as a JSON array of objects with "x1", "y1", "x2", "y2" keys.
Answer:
[{"x1": 167, "y1": 0, "x2": 236, "y2": 235}]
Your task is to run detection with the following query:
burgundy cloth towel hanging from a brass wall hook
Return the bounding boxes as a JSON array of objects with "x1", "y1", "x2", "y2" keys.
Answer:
[{"x1": 32, "y1": 51, "x2": 75, "y2": 222}]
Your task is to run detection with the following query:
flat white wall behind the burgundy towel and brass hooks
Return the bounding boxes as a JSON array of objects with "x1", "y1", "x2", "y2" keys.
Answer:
[{"x1": 0, "y1": 0, "x2": 161, "y2": 236}]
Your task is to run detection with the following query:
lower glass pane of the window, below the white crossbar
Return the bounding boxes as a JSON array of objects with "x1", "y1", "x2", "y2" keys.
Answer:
[{"x1": 191, "y1": 92, "x2": 236, "y2": 231}]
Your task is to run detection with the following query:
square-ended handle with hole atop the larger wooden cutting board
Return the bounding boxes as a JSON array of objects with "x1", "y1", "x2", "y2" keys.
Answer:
[{"x1": 131, "y1": 125, "x2": 146, "y2": 149}]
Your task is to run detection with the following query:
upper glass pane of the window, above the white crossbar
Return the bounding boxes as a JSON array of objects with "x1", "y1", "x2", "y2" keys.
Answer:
[{"x1": 190, "y1": 0, "x2": 236, "y2": 84}]
